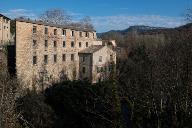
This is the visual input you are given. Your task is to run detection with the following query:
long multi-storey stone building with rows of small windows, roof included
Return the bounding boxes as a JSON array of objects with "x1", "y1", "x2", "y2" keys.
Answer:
[{"x1": 15, "y1": 19, "x2": 115, "y2": 88}]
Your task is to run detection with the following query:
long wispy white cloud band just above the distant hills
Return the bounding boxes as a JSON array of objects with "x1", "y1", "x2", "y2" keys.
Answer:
[{"x1": 92, "y1": 15, "x2": 185, "y2": 32}]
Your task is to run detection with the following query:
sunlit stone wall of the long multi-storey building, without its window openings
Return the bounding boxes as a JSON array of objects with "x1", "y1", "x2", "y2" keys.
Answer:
[{"x1": 16, "y1": 21, "x2": 96, "y2": 88}]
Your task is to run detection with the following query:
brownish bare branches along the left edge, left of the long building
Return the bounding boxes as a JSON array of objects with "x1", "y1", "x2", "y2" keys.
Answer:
[{"x1": 0, "y1": 49, "x2": 23, "y2": 128}]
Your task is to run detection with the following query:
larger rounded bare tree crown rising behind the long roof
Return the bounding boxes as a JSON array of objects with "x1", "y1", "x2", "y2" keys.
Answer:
[{"x1": 39, "y1": 9, "x2": 71, "y2": 25}]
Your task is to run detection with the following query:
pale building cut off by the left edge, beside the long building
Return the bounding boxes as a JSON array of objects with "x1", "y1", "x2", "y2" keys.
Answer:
[{"x1": 0, "y1": 14, "x2": 11, "y2": 46}]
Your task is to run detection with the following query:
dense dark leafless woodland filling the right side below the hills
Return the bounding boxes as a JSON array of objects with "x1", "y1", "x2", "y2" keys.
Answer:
[{"x1": 118, "y1": 24, "x2": 192, "y2": 128}]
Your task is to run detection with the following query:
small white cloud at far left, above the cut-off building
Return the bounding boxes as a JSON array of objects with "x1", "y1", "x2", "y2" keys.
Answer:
[{"x1": 3, "y1": 9, "x2": 37, "y2": 19}]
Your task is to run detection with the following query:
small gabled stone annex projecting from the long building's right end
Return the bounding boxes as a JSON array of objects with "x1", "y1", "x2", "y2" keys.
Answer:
[{"x1": 79, "y1": 45, "x2": 116, "y2": 83}]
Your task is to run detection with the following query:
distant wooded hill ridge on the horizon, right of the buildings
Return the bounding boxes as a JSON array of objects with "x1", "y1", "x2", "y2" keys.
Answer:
[{"x1": 97, "y1": 23, "x2": 192, "y2": 46}]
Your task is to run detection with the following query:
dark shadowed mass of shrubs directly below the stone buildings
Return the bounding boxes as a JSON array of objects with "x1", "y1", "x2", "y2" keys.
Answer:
[{"x1": 17, "y1": 81, "x2": 122, "y2": 128}]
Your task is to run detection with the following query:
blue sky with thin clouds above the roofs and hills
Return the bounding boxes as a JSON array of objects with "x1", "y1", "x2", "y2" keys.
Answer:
[{"x1": 0, "y1": 0, "x2": 192, "y2": 32}]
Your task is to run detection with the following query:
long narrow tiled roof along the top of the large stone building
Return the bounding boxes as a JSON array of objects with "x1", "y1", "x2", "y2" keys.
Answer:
[{"x1": 15, "y1": 18, "x2": 95, "y2": 32}]
